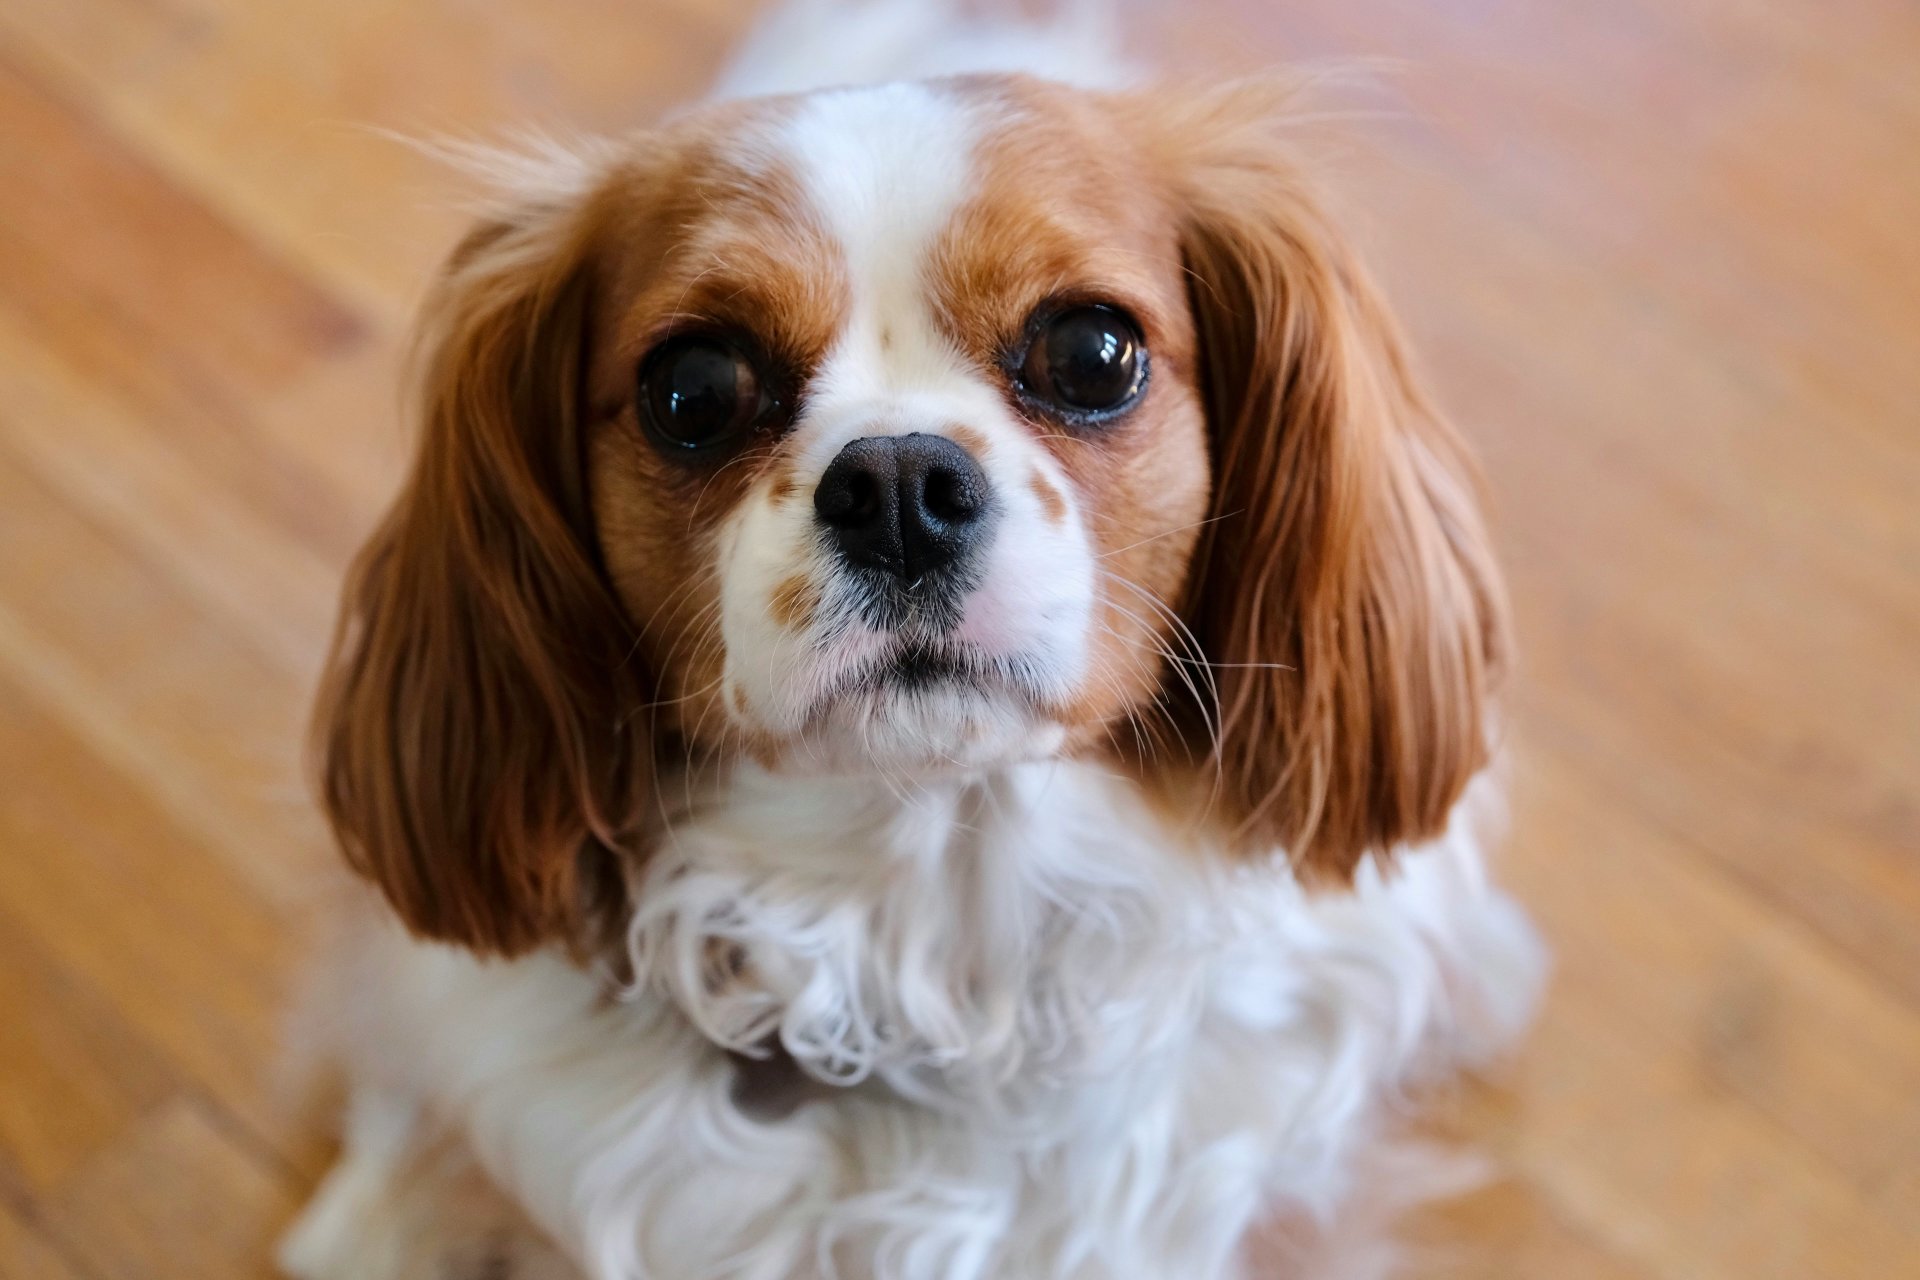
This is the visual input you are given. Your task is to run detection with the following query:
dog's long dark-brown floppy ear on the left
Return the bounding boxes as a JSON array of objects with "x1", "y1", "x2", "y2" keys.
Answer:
[{"x1": 315, "y1": 165, "x2": 651, "y2": 954}]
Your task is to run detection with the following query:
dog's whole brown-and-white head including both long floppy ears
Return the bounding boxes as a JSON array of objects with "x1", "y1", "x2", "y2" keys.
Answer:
[{"x1": 321, "y1": 79, "x2": 1503, "y2": 952}]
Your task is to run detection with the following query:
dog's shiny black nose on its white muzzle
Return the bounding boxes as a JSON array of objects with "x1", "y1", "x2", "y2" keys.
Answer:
[{"x1": 814, "y1": 432, "x2": 989, "y2": 585}]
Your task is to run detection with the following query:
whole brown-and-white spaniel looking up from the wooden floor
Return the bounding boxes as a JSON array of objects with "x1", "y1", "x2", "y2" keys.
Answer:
[{"x1": 282, "y1": 0, "x2": 1542, "y2": 1280}]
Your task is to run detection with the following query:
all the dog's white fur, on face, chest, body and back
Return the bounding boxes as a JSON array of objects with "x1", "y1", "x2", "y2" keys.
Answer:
[{"x1": 282, "y1": 0, "x2": 1542, "y2": 1280}]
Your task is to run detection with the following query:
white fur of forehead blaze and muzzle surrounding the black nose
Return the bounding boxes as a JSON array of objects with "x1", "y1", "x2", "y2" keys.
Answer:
[{"x1": 720, "y1": 84, "x2": 1096, "y2": 764}]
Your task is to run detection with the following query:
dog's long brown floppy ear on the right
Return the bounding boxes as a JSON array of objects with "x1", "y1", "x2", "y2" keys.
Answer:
[{"x1": 1165, "y1": 83, "x2": 1507, "y2": 881}]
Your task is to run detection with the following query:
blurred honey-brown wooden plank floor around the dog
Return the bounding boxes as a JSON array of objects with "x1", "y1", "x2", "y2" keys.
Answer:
[{"x1": 0, "y1": 0, "x2": 1920, "y2": 1280}]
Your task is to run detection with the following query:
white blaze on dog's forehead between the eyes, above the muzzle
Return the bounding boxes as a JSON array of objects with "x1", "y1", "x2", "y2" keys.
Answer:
[{"x1": 780, "y1": 84, "x2": 975, "y2": 397}]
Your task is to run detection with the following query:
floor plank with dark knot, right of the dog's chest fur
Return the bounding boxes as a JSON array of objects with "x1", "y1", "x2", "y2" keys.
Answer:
[{"x1": 1503, "y1": 752, "x2": 1920, "y2": 1196}]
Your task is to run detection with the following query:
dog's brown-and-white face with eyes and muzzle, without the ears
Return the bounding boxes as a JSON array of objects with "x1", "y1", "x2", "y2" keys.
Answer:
[{"x1": 588, "y1": 83, "x2": 1208, "y2": 771}]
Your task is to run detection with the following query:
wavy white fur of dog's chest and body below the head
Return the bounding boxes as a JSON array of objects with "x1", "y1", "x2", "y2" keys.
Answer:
[{"x1": 296, "y1": 764, "x2": 1540, "y2": 1280}]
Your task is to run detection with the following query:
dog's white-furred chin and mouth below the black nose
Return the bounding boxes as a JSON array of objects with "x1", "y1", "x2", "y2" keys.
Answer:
[{"x1": 787, "y1": 647, "x2": 1066, "y2": 775}]
